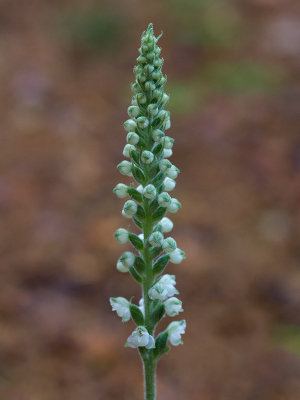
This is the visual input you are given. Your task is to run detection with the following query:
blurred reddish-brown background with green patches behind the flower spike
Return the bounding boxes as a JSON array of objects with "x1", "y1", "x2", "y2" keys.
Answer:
[{"x1": 0, "y1": 0, "x2": 300, "y2": 400}]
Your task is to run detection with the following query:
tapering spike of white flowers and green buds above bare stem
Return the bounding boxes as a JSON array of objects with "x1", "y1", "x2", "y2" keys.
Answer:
[{"x1": 110, "y1": 24, "x2": 186, "y2": 366}]
